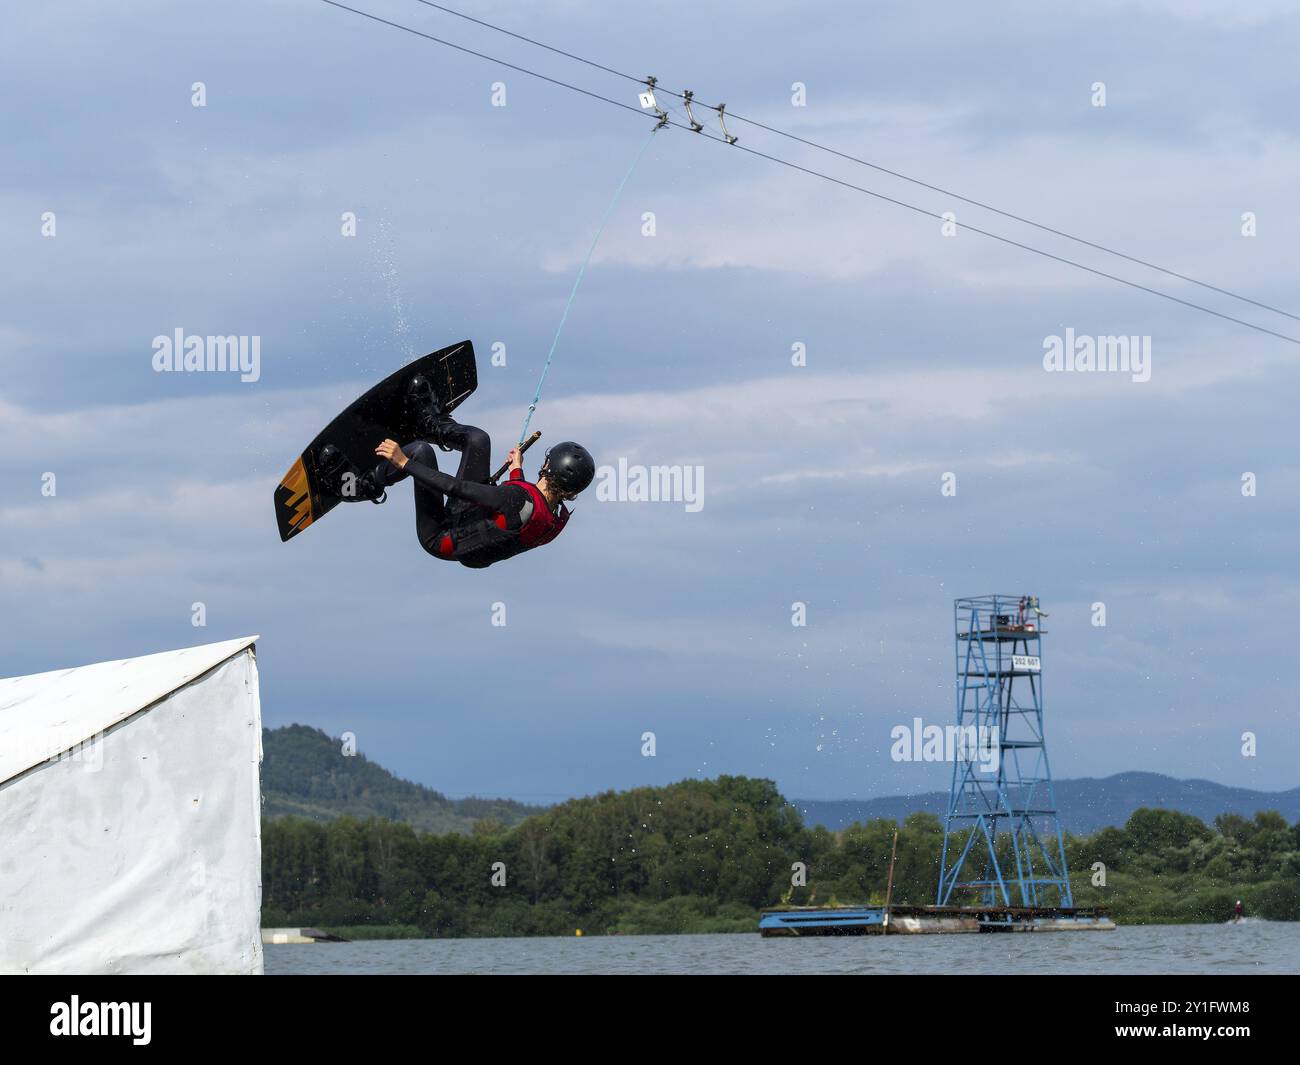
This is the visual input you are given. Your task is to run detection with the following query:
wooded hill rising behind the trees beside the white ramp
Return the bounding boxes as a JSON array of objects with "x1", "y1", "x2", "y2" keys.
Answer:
[{"x1": 261, "y1": 724, "x2": 546, "y2": 832}]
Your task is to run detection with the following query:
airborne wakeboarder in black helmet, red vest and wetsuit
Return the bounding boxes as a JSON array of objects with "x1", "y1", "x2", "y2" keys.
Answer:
[{"x1": 332, "y1": 377, "x2": 595, "y2": 570}]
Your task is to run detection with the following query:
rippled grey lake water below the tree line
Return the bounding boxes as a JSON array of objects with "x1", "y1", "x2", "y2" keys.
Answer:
[{"x1": 265, "y1": 921, "x2": 1300, "y2": 975}]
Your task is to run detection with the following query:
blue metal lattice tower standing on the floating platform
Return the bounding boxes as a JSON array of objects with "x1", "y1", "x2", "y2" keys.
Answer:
[{"x1": 937, "y1": 596, "x2": 1074, "y2": 908}]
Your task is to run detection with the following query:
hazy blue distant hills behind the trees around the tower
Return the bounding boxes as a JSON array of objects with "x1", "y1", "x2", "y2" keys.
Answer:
[{"x1": 792, "y1": 772, "x2": 1300, "y2": 836}]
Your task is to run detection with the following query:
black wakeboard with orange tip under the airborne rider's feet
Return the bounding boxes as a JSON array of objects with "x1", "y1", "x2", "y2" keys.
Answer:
[{"x1": 276, "y1": 341, "x2": 478, "y2": 541}]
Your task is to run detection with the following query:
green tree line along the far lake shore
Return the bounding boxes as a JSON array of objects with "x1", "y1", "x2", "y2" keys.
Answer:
[{"x1": 263, "y1": 776, "x2": 1300, "y2": 939}]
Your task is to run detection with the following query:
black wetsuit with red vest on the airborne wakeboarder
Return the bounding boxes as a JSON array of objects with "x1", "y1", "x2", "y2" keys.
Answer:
[{"x1": 381, "y1": 419, "x2": 568, "y2": 568}]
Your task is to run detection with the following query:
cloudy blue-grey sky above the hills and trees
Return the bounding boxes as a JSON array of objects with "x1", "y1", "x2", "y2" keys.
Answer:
[{"x1": 0, "y1": 0, "x2": 1300, "y2": 801}]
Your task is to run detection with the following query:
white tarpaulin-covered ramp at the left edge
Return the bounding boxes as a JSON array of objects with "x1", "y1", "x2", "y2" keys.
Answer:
[{"x1": 0, "y1": 636, "x2": 263, "y2": 973}]
